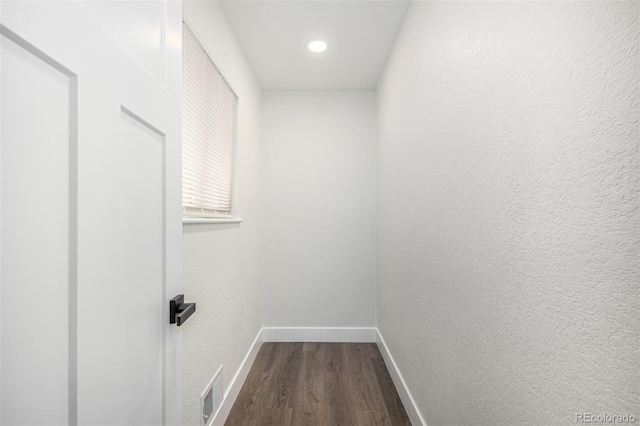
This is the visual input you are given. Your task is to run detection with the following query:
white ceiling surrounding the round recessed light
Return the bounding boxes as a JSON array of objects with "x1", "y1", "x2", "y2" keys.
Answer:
[{"x1": 220, "y1": 0, "x2": 410, "y2": 90}]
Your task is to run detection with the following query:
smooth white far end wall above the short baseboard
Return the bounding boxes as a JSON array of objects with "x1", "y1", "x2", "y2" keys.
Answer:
[{"x1": 261, "y1": 92, "x2": 376, "y2": 327}]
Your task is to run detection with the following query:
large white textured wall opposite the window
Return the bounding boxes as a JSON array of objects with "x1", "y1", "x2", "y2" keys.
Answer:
[{"x1": 377, "y1": 2, "x2": 640, "y2": 426}]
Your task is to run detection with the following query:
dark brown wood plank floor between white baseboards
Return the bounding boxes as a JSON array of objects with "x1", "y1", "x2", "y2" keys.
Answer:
[{"x1": 226, "y1": 343, "x2": 411, "y2": 426}]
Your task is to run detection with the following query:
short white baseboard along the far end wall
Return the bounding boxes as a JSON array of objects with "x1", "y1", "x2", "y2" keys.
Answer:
[{"x1": 262, "y1": 327, "x2": 377, "y2": 343}]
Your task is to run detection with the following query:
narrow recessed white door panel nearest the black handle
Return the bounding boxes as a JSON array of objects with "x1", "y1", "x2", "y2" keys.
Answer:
[{"x1": 117, "y1": 110, "x2": 166, "y2": 425}]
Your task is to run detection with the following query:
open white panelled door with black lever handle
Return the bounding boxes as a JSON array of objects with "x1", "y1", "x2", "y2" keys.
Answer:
[{"x1": 0, "y1": 0, "x2": 189, "y2": 425}]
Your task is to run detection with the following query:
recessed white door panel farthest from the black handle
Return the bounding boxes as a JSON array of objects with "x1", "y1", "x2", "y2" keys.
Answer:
[{"x1": 0, "y1": 28, "x2": 76, "y2": 425}]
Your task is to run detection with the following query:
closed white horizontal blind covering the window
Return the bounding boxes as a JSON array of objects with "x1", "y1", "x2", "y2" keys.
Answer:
[{"x1": 182, "y1": 23, "x2": 238, "y2": 218}]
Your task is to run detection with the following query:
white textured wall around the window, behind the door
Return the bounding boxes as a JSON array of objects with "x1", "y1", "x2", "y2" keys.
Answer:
[{"x1": 182, "y1": 1, "x2": 262, "y2": 425}]
